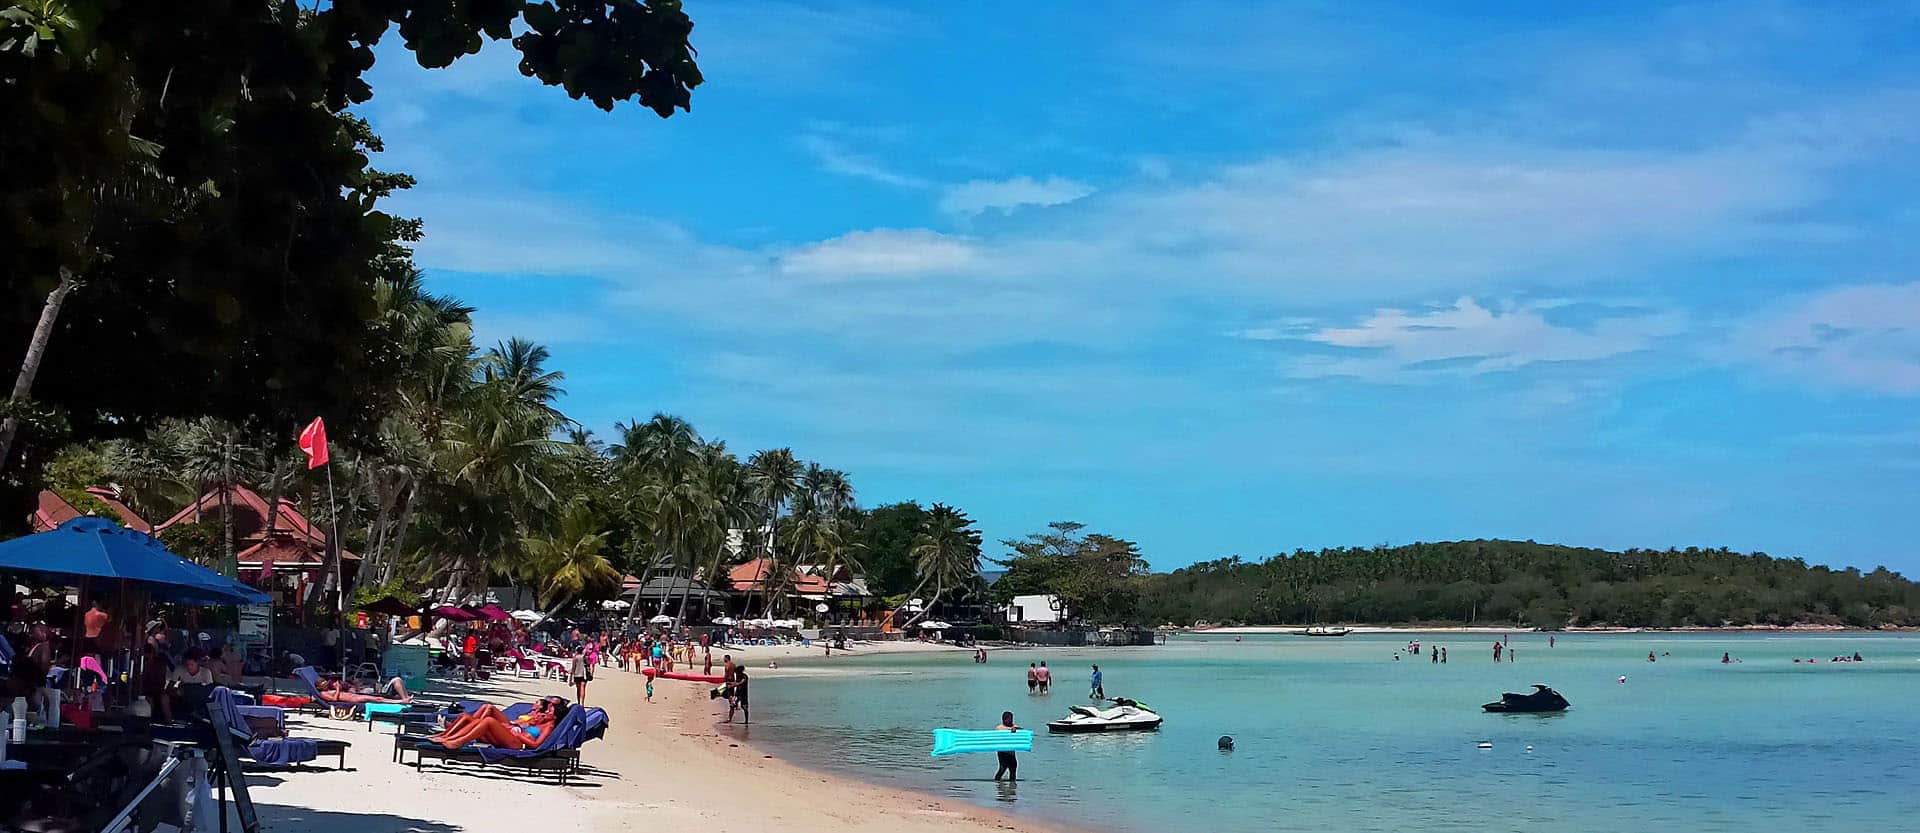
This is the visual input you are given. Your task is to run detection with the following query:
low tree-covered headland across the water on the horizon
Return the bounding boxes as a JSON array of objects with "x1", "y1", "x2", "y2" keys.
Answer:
[{"x1": 1137, "y1": 541, "x2": 1920, "y2": 628}]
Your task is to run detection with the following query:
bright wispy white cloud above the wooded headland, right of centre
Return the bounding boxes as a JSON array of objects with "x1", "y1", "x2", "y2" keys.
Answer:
[{"x1": 1246, "y1": 298, "x2": 1682, "y2": 380}]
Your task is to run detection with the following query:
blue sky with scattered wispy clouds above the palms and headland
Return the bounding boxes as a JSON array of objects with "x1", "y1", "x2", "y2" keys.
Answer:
[{"x1": 361, "y1": 0, "x2": 1920, "y2": 572}]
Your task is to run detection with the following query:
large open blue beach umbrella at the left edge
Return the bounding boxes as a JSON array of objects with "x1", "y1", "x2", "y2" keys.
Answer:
[{"x1": 0, "y1": 518, "x2": 273, "y2": 605}]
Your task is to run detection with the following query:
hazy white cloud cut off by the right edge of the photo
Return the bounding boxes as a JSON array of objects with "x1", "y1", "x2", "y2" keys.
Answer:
[{"x1": 1726, "y1": 282, "x2": 1920, "y2": 395}]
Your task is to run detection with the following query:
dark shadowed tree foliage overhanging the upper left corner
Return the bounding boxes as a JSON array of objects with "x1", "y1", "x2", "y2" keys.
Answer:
[{"x1": 0, "y1": 0, "x2": 701, "y2": 533}]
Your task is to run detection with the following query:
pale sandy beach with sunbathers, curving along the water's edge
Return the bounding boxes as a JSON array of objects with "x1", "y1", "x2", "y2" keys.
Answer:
[{"x1": 224, "y1": 643, "x2": 1050, "y2": 833}]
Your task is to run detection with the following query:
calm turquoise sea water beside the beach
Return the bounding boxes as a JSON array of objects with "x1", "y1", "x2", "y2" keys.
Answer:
[{"x1": 753, "y1": 633, "x2": 1920, "y2": 833}]
